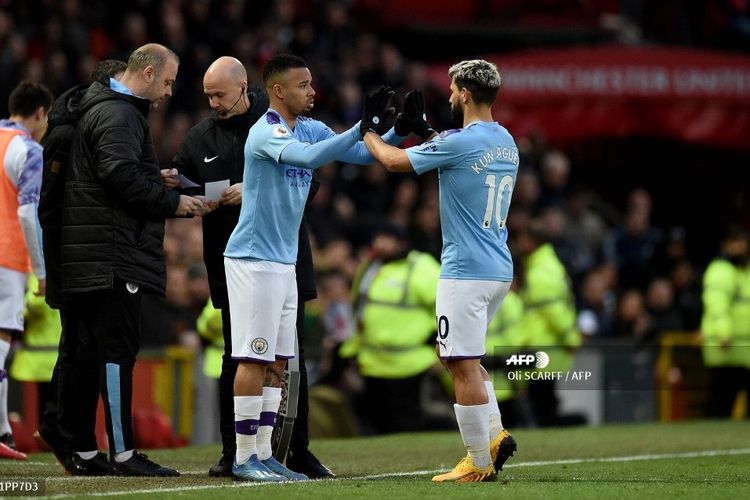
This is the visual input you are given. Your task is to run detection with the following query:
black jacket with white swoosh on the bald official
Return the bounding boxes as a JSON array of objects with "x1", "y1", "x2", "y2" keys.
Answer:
[{"x1": 172, "y1": 88, "x2": 316, "y2": 308}]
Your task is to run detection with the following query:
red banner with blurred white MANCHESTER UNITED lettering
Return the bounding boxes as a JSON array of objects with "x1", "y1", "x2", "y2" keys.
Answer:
[{"x1": 430, "y1": 47, "x2": 750, "y2": 150}]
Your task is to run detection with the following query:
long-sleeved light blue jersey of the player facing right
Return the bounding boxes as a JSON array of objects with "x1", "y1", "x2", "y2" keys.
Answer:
[{"x1": 224, "y1": 109, "x2": 401, "y2": 264}]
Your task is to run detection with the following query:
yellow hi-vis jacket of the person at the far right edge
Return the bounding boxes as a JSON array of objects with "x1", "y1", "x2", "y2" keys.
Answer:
[{"x1": 701, "y1": 259, "x2": 750, "y2": 368}]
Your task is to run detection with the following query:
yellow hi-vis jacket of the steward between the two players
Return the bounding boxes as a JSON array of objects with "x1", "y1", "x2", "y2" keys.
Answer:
[{"x1": 339, "y1": 251, "x2": 440, "y2": 379}]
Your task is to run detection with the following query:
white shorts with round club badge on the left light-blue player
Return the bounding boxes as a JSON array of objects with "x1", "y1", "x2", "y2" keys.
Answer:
[{"x1": 224, "y1": 257, "x2": 297, "y2": 363}]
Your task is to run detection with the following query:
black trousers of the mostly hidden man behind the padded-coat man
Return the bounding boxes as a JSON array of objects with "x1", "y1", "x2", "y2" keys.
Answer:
[{"x1": 39, "y1": 307, "x2": 99, "y2": 454}]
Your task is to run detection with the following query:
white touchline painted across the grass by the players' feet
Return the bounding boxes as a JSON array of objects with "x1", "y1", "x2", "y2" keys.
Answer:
[{"x1": 38, "y1": 448, "x2": 750, "y2": 498}]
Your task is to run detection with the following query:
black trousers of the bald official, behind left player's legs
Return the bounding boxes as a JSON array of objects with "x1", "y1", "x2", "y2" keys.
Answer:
[{"x1": 219, "y1": 299, "x2": 310, "y2": 456}]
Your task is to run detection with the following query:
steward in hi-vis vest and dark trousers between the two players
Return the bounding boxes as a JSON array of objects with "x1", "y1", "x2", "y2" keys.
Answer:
[{"x1": 340, "y1": 225, "x2": 440, "y2": 432}]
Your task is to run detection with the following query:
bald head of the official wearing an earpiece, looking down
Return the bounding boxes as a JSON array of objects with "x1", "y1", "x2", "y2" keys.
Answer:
[{"x1": 203, "y1": 56, "x2": 250, "y2": 120}]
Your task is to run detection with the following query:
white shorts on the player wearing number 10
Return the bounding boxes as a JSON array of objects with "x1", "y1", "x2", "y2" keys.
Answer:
[{"x1": 435, "y1": 278, "x2": 510, "y2": 359}]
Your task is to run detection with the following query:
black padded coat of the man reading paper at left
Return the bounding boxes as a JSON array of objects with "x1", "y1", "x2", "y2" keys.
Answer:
[{"x1": 61, "y1": 82, "x2": 180, "y2": 295}]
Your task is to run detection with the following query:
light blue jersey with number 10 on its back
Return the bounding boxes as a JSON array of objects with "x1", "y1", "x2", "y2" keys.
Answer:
[{"x1": 406, "y1": 121, "x2": 519, "y2": 281}]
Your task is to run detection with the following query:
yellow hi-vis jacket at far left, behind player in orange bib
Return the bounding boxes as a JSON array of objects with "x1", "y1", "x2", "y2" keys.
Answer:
[{"x1": 10, "y1": 275, "x2": 62, "y2": 382}]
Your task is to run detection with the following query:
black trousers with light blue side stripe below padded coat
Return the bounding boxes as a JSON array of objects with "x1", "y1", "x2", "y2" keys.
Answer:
[{"x1": 71, "y1": 278, "x2": 143, "y2": 455}]
